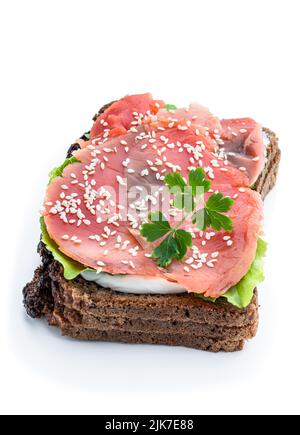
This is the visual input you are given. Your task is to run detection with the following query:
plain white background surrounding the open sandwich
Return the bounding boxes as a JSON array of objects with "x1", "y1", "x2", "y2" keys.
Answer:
[{"x1": 0, "y1": 0, "x2": 300, "y2": 414}]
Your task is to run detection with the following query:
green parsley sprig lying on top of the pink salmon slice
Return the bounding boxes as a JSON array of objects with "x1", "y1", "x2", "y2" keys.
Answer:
[{"x1": 141, "y1": 168, "x2": 234, "y2": 268}]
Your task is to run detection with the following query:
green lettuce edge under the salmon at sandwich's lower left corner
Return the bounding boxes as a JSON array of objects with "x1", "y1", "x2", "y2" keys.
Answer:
[{"x1": 40, "y1": 217, "x2": 90, "y2": 280}]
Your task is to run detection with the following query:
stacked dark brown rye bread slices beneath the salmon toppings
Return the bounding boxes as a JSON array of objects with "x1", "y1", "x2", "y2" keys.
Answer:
[{"x1": 23, "y1": 105, "x2": 280, "y2": 352}]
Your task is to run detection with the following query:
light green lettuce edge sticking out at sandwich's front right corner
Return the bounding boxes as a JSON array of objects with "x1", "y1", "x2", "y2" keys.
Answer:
[{"x1": 195, "y1": 239, "x2": 268, "y2": 309}]
